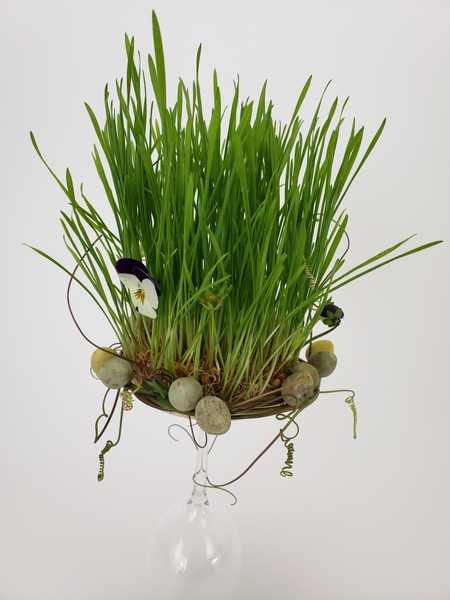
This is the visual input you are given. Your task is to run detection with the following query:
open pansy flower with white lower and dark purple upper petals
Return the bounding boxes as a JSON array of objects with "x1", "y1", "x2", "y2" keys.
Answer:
[{"x1": 116, "y1": 258, "x2": 161, "y2": 319}]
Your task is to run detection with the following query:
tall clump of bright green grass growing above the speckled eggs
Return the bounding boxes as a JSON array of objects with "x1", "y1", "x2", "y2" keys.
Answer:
[{"x1": 32, "y1": 13, "x2": 437, "y2": 416}]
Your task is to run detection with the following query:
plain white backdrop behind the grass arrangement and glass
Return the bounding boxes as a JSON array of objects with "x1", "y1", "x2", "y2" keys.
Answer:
[{"x1": 0, "y1": 0, "x2": 450, "y2": 600}]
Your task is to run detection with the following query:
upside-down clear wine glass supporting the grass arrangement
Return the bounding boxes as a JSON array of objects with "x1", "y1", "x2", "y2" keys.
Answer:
[{"x1": 146, "y1": 432, "x2": 241, "y2": 600}]
